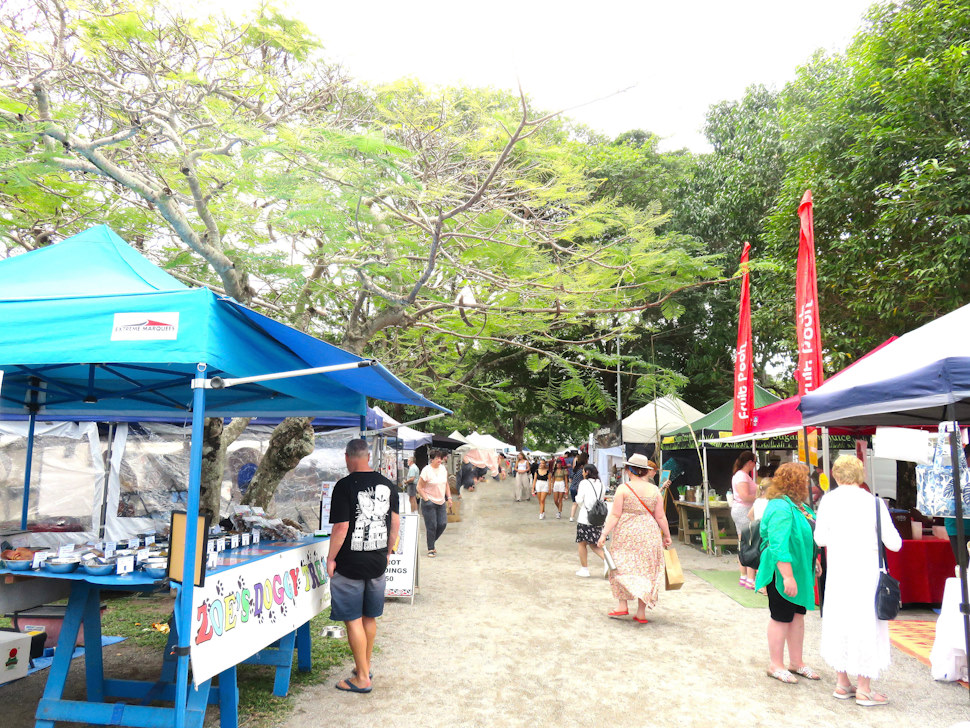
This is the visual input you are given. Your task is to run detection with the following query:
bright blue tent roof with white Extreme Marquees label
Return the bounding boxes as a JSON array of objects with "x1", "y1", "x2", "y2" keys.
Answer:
[{"x1": 0, "y1": 225, "x2": 447, "y2": 419}]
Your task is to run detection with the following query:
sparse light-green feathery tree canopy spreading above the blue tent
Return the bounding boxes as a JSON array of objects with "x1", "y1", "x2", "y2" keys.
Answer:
[{"x1": 0, "y1": 0, "x2": 718, "y2": 456}]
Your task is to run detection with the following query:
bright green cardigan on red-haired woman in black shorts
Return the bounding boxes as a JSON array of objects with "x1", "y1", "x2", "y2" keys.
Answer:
[{"x1": 755, "y1": 496, "x2": 815, "y2": 610}]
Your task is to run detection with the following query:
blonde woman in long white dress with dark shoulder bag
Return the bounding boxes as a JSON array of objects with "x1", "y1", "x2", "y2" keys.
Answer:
[{"x1": 815, "y1": 455, "x2": 903, "y2": 707}]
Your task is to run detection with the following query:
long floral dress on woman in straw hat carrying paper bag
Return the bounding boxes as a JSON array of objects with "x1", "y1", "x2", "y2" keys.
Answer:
[{"x1": 610, "y1": 486, "x2": 664, "y2": 607}]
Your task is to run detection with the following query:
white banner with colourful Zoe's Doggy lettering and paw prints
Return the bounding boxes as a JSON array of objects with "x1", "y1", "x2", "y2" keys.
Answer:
[{"x1": 189, "y1": 541, "x2": 330, "y2": 685}]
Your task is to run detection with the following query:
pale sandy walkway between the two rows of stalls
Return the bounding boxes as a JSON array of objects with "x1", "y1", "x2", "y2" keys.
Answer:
[{"x1": 282, "y1": 480, "x2": 970, "y2": 728}]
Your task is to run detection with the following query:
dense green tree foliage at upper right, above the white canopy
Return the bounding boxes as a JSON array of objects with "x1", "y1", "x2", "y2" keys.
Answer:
[{"x1": 767, "y1": 0, "x2": 970, "y2": 366}]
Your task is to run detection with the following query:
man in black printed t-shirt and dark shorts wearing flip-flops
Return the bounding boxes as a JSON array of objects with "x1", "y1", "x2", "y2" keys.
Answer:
[{"x1": 327, "y1": 440, "x2": 401, "y2": 693}]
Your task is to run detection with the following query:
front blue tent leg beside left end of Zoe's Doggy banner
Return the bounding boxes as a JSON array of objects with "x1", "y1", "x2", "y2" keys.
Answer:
[{"x1": 174, "y1": 364, "x2": 206, "y2": 728}]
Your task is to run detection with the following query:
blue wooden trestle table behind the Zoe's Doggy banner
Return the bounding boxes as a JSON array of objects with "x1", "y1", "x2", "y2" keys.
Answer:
[{"x1": 0, "y1": 546, "x2": 324, "y2": 728}]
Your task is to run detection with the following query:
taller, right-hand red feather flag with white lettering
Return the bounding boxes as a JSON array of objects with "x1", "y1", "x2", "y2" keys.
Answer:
[{"x1": 795, "y1": 190, "x2": 823, "y2": 395}]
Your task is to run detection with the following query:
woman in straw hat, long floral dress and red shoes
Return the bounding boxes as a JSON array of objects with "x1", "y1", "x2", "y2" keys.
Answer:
[{"x1": 596, "y1": 453, "x2": 671, "y2": 624}]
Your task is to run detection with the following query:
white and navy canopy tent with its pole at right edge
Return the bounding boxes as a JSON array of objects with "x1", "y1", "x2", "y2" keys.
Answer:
[{"x1": 799, "y1": 306, "x2": 970, "y2": 700}]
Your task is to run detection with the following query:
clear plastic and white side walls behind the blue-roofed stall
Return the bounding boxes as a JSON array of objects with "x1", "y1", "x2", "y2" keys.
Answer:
[{"x1": 0, "y1": 422, "x2": 364, "y2": 546}]
